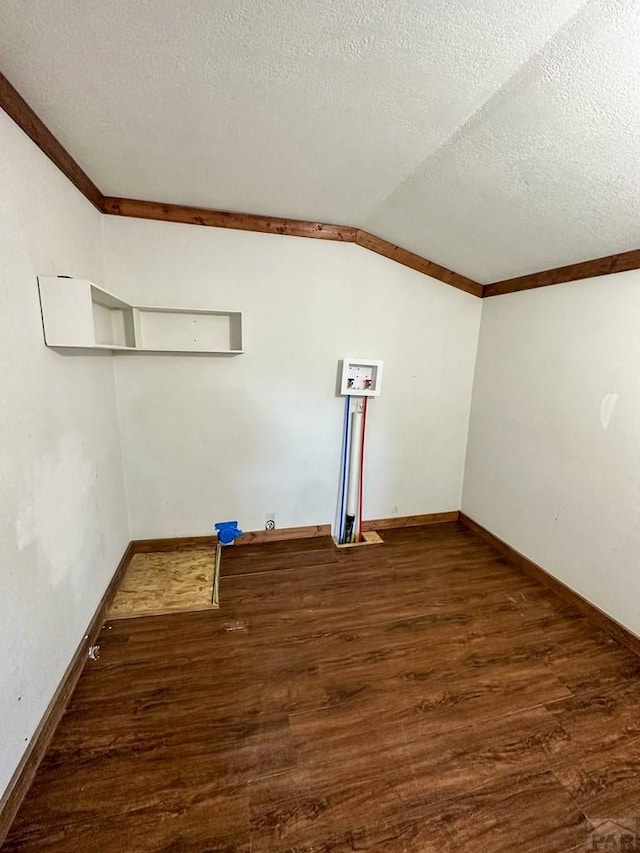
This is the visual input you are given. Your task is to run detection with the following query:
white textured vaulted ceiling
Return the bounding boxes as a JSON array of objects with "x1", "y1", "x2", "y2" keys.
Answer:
[{"x1": 0, "y1": 0, "x2": 640, "y2": 283}]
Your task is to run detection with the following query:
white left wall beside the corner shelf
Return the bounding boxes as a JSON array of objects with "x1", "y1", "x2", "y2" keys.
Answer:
[{"x1": 0, "y1": 111, "x2": 128, "y2": 792}]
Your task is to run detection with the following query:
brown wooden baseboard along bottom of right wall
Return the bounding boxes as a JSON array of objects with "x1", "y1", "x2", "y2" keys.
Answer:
[{"x1": 460, "y1": 512, "x2": 640, "y2": 655}]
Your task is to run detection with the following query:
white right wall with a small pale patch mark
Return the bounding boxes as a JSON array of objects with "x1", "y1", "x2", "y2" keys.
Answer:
[{"x1": 462, "y1": 271, "x2": 640, "y2": 633}]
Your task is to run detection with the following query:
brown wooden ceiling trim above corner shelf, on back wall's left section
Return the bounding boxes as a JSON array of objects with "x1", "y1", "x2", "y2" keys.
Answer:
[{"x1": 103, "y1": 196, "x2": 356, "y2": 243}]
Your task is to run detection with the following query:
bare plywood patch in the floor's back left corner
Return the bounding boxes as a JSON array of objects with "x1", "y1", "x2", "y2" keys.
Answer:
[{"x1": 108, "y1": 548, "x2": 215, "y2": 619}]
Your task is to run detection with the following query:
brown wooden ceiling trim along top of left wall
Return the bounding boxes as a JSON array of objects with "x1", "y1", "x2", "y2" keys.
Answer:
[{"x1": 0, "y1": 73, "x2": 103, "y2": 212}]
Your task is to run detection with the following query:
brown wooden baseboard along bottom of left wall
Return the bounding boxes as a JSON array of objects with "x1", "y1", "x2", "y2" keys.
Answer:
[{"x1": 0, "y1": 543, "x2": 133, "y2": 847}]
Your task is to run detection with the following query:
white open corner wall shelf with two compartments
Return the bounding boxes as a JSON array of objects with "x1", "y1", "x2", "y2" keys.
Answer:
[{"x1": 38, "y1": 276, "x2": 243, "y2": 355}]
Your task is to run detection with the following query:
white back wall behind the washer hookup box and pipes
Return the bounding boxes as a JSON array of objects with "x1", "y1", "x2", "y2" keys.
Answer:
[{"x1": 104, "y1": 217, "x2": 481, "y2": 538}]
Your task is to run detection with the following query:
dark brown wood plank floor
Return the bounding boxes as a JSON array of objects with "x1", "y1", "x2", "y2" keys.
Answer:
[{"x1": 5, "y1": 524, "x2": 640, "y2": 853}]
